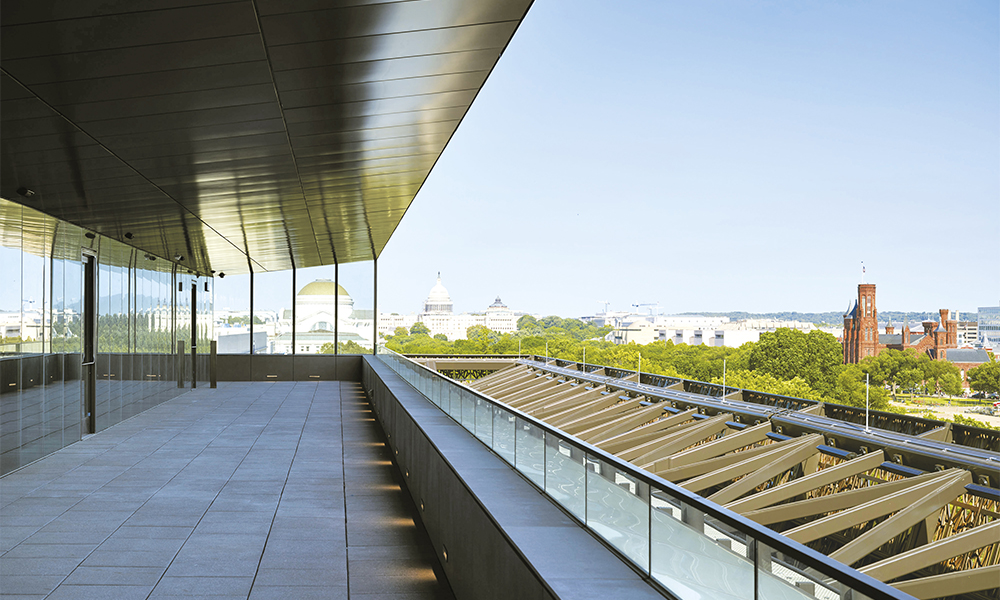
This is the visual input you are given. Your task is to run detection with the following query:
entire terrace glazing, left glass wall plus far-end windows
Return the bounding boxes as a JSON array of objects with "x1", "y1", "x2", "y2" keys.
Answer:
[{"x1": 0, "y1": 199, "x2": 377, "y2": 473}]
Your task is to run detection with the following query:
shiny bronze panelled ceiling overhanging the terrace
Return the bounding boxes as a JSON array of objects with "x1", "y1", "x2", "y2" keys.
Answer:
[{"x1": 0, "y1": 0, "x2": 531, "y2": 273}]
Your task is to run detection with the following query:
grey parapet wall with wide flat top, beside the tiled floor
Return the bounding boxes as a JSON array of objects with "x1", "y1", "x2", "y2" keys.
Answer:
[{"x1": 362, "y1": 356, "x2": 663, "y2": 600}]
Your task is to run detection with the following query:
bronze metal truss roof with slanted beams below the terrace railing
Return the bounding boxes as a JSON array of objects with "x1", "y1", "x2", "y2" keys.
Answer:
[{"x1": 468, "y1": 359, "x2": 1000, "y2": 599}]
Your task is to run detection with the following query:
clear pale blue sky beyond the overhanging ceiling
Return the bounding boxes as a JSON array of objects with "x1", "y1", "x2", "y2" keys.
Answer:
[{"x1": 374, "y1": 0, "x2": 1000, "y2": 316}]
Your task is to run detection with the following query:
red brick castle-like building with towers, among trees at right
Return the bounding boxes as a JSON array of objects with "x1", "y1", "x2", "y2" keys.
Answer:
[{"x1": 841, "y1": 283, "x2": 990, "y2": 387}]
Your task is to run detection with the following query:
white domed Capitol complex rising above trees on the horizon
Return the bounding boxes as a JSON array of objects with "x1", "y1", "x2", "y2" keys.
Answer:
[{"x1": 378, "y1": 273, "x2": 527, "y2": 341}]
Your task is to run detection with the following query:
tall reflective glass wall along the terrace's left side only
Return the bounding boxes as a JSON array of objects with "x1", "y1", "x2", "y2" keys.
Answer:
[{"x1": 0, "y1": 199, "x2": 193, "y2": 473}]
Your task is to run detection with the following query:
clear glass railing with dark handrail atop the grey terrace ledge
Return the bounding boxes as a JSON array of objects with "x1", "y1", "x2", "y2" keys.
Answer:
[{"x1": 377, "y1": 347, "x2": 912, "y2": 600}]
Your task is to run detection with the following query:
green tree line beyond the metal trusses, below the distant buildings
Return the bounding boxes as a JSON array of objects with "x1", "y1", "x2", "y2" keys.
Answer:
[{"x1": 386, "y1": 316, "x2": 1000, "y2": 410}]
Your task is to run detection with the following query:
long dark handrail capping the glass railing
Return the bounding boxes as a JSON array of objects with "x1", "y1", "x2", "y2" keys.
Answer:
[{"x1": 376, "y1": 347, "x2": 913, "y2": 600}]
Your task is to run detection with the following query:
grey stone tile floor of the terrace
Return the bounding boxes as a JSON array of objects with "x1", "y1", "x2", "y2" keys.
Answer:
[{"x1": 0, "y1": 381, "x2": 453, "y2": 600}]
